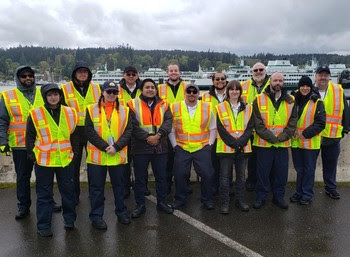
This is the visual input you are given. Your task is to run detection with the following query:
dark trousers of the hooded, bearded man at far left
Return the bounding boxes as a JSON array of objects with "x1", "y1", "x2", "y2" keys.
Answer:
[{"x1": 12, "y1": 149, "x2": 34, "y2": 211}]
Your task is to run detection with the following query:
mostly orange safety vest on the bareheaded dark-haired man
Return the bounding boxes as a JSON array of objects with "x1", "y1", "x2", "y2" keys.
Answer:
[{"x1": 128, "y1": 98, "x2": 169, "y2": 134}]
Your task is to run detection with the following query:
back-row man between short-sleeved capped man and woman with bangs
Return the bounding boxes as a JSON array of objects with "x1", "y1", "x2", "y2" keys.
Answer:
[{"x1": 202, "y1": 72, "x2": 227, "y2": 195}]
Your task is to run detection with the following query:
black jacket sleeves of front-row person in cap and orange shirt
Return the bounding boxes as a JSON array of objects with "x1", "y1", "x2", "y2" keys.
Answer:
[{"x1": 85, "y1": 105, "x2": 132, "y2": 152}]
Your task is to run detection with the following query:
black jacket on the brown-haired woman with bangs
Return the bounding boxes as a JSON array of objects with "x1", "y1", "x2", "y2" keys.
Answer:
[{"x1": 216, "y1": 99, "x2": 254, "y2": 156}]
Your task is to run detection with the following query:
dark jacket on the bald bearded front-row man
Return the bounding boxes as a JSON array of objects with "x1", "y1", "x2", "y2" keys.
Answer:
[{"x1": 253, "y1": 87, "x2": 298, "y2": 144}]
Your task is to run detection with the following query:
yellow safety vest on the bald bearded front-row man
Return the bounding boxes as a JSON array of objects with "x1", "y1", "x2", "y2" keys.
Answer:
[{"x1": 253, "y1": 93, "x2": 294, "y2": 147}]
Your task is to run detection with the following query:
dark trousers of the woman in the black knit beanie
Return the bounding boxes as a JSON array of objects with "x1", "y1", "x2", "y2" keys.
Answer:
[{"x1": 292, "y1": 148, "x2": 320, "y2": 201}]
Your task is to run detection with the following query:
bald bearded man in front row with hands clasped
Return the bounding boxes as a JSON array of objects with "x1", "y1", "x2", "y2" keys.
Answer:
[{"x1": 253, "y1": 72, "x2": 298, "y2": 209}]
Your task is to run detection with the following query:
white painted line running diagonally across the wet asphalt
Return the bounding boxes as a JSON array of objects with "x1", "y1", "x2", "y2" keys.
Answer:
[{"x1": 146, "y1": 195, "x2": 263, "y2": 257}]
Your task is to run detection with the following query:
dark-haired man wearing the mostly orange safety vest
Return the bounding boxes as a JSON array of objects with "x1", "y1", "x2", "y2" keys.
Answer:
[{"x1": 128, "y1": 79, "x2": 174, "y2": 218}]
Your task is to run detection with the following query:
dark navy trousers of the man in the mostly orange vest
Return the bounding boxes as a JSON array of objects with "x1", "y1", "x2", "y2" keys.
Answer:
[{"x1": 133, "y1": 153, "x2": 168, "y2": 205}]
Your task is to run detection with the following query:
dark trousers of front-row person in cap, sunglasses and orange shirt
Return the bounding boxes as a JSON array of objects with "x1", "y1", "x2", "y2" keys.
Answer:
[{"x1": 87, "y1": 164, "x2": 127, "y2": 221}]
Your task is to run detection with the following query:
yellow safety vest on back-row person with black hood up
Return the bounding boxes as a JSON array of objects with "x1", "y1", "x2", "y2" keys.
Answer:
[{"x1": 61, "y1": 81, "x2": 101, "y2": 126}]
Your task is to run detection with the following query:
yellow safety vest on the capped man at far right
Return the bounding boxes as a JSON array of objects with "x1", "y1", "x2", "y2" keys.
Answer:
[{"x1": 321, "y1": 82, "x2": 344, "y2": 138}]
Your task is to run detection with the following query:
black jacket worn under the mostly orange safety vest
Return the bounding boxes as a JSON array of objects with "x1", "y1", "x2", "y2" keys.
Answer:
[{"x1": 130, "y1": 95, "x2": 173, "y2": 154}]
